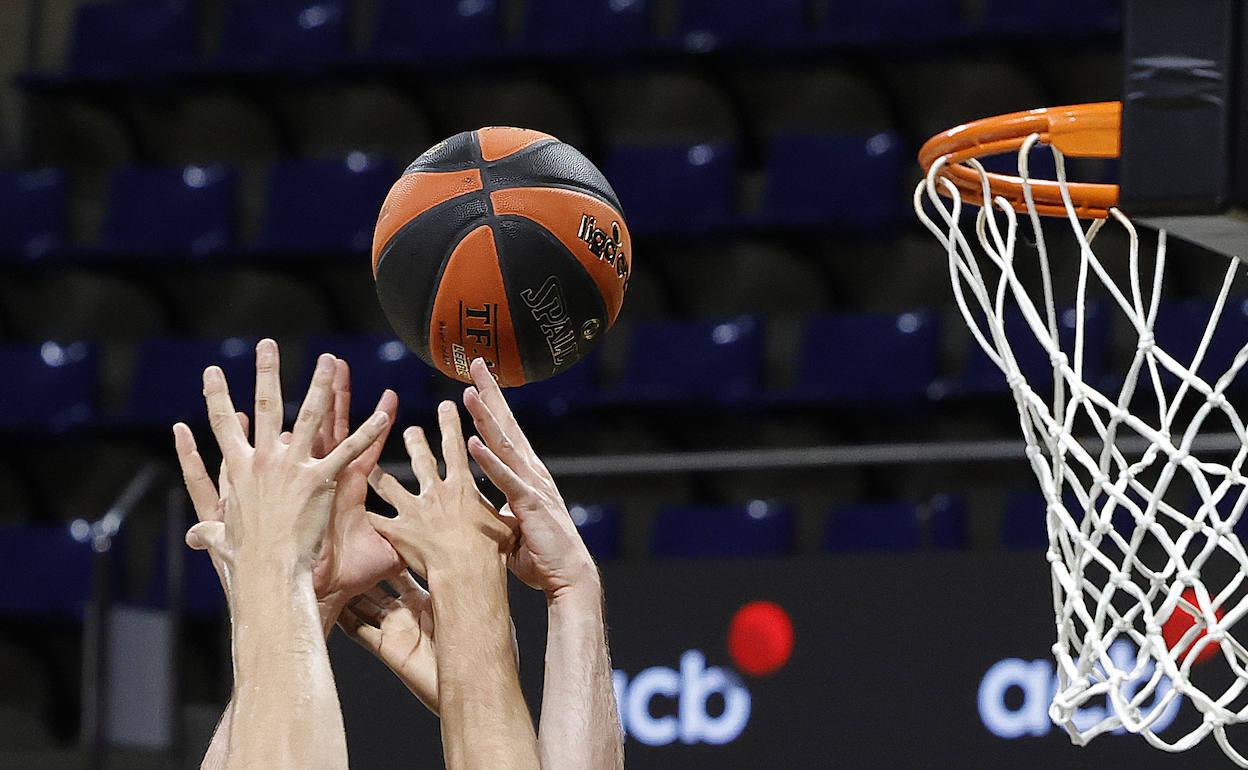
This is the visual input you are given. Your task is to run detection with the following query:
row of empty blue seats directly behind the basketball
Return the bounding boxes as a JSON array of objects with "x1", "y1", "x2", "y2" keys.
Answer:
[{"x1": 0, "y1": 134, "x2": 906, "y2": 260}]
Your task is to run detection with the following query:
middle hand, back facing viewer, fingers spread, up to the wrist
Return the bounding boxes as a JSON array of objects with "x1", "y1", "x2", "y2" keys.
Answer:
[{"x1": 368, "y1": 401, "x2": 513, "y2": 580}]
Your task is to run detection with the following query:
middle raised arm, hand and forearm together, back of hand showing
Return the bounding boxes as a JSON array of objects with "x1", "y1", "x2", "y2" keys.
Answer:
[{"x1": 368, "y1": 402, "x2": 540, "y2": 770}]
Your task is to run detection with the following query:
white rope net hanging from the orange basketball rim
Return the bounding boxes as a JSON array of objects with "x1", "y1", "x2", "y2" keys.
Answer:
[{"x1": 914, "y1": 135, "x2": 1248, "y2": 768}]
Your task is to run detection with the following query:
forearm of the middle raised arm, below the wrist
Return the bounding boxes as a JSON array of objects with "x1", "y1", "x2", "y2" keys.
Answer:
[{"x1": 429, "y1": 558, "x2": 540, "y2": 770}]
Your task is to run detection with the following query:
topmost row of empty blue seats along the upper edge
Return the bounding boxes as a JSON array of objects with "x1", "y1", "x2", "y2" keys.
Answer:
[{"x1": 53, "y1": 0, "x2": 1119, "y2": 77}]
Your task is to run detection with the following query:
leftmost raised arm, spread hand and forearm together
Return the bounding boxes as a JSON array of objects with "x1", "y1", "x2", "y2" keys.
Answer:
[{"x1": 175, "y1": 339, "x2": 391, "y2": 770}]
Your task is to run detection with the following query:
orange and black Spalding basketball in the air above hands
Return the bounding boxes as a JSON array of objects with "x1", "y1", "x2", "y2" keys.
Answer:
[{"x1": 372, "y1": 127, "x2": 633, "y2": 387}]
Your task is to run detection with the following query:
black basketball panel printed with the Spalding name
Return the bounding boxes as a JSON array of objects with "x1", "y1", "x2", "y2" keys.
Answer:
[{"x1": 494, "y1": 216, "x2": 607, "y2": 382}]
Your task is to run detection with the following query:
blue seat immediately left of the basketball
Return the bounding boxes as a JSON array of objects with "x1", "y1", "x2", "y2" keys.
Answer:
[{"x1": 257, "y1": 152, "x2": 398, "y2": 255}]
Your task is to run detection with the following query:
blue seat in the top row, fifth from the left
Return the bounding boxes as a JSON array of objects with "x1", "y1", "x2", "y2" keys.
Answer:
[{"x1": 676, "y1": 0, "x2": 807, "y2": 52}]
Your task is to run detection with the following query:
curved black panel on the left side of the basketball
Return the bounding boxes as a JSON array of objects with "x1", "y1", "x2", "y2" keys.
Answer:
[{"x1": 377, "y1": 192, "x2": 487, "y2": 367}]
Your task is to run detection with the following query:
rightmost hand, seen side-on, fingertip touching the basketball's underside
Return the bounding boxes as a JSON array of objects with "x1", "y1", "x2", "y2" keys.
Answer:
[{"x1": 464, "y1": 358, "x2": 599, "y2": 599}]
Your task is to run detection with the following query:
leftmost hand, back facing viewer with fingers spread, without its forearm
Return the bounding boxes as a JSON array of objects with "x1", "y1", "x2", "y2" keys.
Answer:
[{"x1": 175, "y1": 339, "x2": 389, "y2": 579}]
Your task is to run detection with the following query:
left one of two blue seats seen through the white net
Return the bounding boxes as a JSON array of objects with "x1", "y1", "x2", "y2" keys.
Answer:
[{"x1": 952, "y1": 302, "x2": 1111, "y2": 396}]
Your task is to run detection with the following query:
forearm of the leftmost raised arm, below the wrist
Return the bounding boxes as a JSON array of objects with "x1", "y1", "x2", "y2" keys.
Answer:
[{"x1": 225, "y1": 559, "x2": 347, "y2": 770}]
